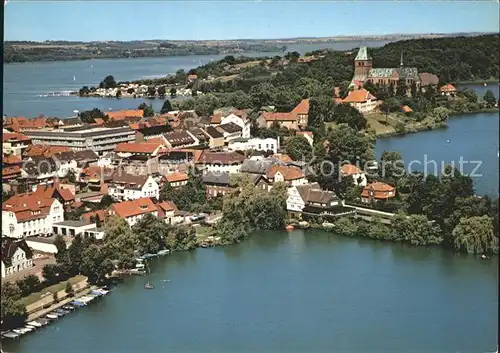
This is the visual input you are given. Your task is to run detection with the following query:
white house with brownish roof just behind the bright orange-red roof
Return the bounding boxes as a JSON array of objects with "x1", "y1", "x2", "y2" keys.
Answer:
[{"x1": 108, "y1": 169, "x2": 160, "y2": 201}]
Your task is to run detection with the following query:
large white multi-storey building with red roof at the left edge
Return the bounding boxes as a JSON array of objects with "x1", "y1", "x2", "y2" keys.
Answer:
[{"x1": 2, "y1": 193, "x2": 64, "y2": 239}]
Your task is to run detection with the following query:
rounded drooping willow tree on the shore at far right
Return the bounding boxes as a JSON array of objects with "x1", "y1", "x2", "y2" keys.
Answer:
[{"x1": 452, "y1": 215, "x2": 498, "y2": 254}]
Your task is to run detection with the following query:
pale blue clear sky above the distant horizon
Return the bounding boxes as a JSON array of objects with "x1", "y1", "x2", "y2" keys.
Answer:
[{"x1": 4, "y1": 0, "x2": 499, "y2": 41}]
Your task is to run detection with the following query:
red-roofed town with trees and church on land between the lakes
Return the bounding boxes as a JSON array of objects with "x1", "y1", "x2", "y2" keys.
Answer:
[{"x1": 1, "y1": 41, "x2": 498, "y2": 337}]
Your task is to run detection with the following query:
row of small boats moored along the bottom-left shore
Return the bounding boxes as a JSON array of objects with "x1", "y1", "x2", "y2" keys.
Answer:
[{"x1": 2, "y1": 287, "x2": 109, "y2": 339}]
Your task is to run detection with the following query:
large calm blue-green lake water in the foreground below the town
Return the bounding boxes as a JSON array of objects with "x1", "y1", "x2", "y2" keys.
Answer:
[{"x1": 4, "y1": 230, "x2": 498, "y2": 353}]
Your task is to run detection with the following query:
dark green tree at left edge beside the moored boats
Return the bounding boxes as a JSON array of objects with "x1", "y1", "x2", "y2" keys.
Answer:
[{"x1": 0, "y1": 282, "x2": 28, "y2": 329}]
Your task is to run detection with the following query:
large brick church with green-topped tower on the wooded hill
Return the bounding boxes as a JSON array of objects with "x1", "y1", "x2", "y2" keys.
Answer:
[{"x1": 349, "y1": 47, "x2": 420, "y2": 88}]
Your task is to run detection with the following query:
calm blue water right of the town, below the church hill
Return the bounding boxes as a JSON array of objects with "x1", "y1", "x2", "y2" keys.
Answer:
[{"x1": 376, "y1": 113, "x2": 499, "y2": 197}]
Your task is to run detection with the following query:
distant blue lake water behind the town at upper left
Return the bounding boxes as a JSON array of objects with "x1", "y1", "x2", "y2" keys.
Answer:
[{"x1": 3, "y1": 41, "x2": 387, "y2": 117}]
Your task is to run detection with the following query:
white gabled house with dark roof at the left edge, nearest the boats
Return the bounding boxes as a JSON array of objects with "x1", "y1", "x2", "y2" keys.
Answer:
[{"x1": 2, "y1": 238, "x2": 33, "y2": 278}]
